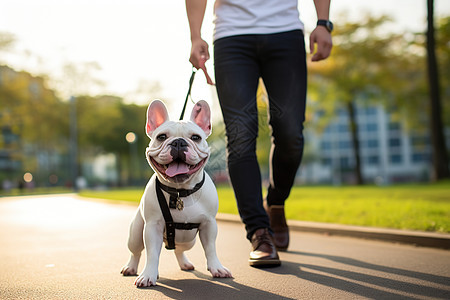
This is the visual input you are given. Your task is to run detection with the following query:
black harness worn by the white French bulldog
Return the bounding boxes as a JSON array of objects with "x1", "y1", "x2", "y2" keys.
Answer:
[{"x1": 156, "y1": 173, "x2": 205, "y2": 250}]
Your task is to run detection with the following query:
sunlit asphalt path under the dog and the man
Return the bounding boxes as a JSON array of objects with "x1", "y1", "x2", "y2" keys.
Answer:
[{"x1": 0, "y1": 195, "x2": 450, "y2": 300}]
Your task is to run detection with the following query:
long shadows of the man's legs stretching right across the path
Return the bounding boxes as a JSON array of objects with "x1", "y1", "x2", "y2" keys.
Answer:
[{"x1": 267, "y1": 251, "x2": 450, "y2": 299}]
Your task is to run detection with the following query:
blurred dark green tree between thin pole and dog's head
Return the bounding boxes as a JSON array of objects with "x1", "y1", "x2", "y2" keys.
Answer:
[{"x1": 77, "y1": 95, "x2": 150, "y2": 185}]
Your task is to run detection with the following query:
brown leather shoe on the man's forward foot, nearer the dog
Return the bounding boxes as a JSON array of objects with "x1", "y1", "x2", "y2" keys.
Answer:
[{"x1": 248, "y1": 228, "x2": 281, "y2": 268}]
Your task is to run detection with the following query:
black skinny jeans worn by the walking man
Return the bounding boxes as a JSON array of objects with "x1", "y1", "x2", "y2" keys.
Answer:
[{"x1": 214, "y1": 30, "x2": 306, "y2": 239}]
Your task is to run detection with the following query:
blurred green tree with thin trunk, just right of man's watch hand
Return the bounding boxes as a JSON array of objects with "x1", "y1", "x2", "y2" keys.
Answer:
[{"x1": 309, "y1": 16, "x2": 401, "y2": 184}]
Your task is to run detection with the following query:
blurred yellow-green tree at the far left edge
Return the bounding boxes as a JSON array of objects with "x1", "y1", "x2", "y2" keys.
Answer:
[{"x1": 0, "y1": 66, "x2": 68, "y2": 183}]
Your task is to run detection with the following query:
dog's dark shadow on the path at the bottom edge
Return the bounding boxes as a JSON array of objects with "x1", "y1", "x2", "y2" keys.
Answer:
[{"x1": 139, "y1": 270, "x2": 293, "y2": 299}]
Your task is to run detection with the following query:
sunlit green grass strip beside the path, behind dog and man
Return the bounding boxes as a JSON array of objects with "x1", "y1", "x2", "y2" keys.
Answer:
[{"x1": 80, "y1": 182, "x2": 450, "y2": 233}]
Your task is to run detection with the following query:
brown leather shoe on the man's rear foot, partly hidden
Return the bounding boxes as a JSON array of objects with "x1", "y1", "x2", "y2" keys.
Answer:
[{"x1": 266, "y1": 205, "x2": 289, "y2": 251}]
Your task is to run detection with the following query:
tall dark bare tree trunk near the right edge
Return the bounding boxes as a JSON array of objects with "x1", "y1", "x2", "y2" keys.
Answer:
[{"x1": 426, "y1": 0, "x2": 450, "y2": 180}]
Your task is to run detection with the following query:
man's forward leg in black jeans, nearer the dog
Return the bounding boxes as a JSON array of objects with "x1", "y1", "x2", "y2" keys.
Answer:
[{"x1": 214, "y1": 35, "x2": 270, "y2": 240}]
